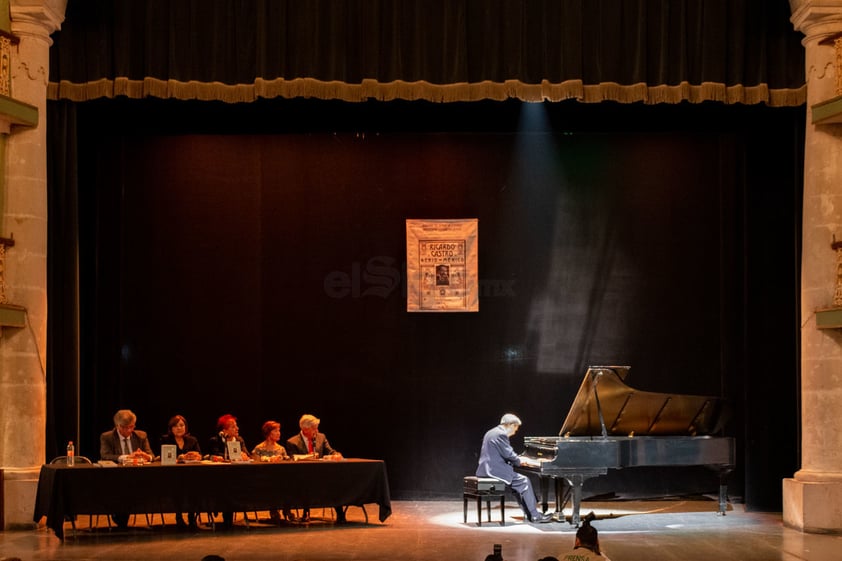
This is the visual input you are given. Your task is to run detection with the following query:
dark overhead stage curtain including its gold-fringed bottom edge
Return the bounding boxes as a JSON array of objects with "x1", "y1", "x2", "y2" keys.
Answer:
[{"x1": 49, "y1": 0, "x2": 806, "y2": 105}]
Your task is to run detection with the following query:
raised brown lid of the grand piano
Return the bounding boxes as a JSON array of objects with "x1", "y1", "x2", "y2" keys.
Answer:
[{"x1": 559, "y1": 366, "x2": 725, "y2": 436}]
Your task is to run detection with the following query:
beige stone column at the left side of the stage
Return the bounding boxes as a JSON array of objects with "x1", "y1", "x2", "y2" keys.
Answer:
[{"x1": 0, "y1": 0, "x2": 67, "y2": 529}]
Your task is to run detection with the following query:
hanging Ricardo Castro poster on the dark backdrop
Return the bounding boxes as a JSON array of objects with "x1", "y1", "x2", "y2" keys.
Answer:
[{"x1": 406, "y1": 218, "x2": 479, "y2": 312}]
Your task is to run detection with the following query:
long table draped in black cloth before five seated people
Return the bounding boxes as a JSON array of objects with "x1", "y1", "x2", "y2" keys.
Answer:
[{"x1": 33, "y1": 459, "x2": 392, "y2": 539}]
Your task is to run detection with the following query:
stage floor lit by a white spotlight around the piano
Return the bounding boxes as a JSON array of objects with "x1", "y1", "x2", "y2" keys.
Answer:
[{"x1": 0, "y1": 499, "x2": 842, "y2": 561}]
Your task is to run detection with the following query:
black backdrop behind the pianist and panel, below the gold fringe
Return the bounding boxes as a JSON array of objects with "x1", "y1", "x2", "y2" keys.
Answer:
[{"x1": 48, "y1": 99, "x2": 800, "y2": 509}]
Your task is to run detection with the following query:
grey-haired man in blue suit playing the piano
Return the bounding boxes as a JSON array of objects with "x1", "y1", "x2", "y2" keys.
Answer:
[{"x1": 477, "y1": 413, "x2": 552, "y2": 523}]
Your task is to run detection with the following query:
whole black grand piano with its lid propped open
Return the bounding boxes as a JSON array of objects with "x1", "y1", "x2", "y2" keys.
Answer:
[{"x1": 518, "y1": 366, "x2": 734, "y2": 526}]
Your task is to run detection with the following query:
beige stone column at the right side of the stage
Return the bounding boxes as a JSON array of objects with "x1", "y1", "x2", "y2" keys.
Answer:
[{"x1": 783, "y1": 0, "x2": 842, "y2": 532}]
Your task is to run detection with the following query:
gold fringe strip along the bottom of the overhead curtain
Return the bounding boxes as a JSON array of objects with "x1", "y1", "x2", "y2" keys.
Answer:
[{"x1": 47, "y1": 78, "x2": 807, "y2": 107}]
